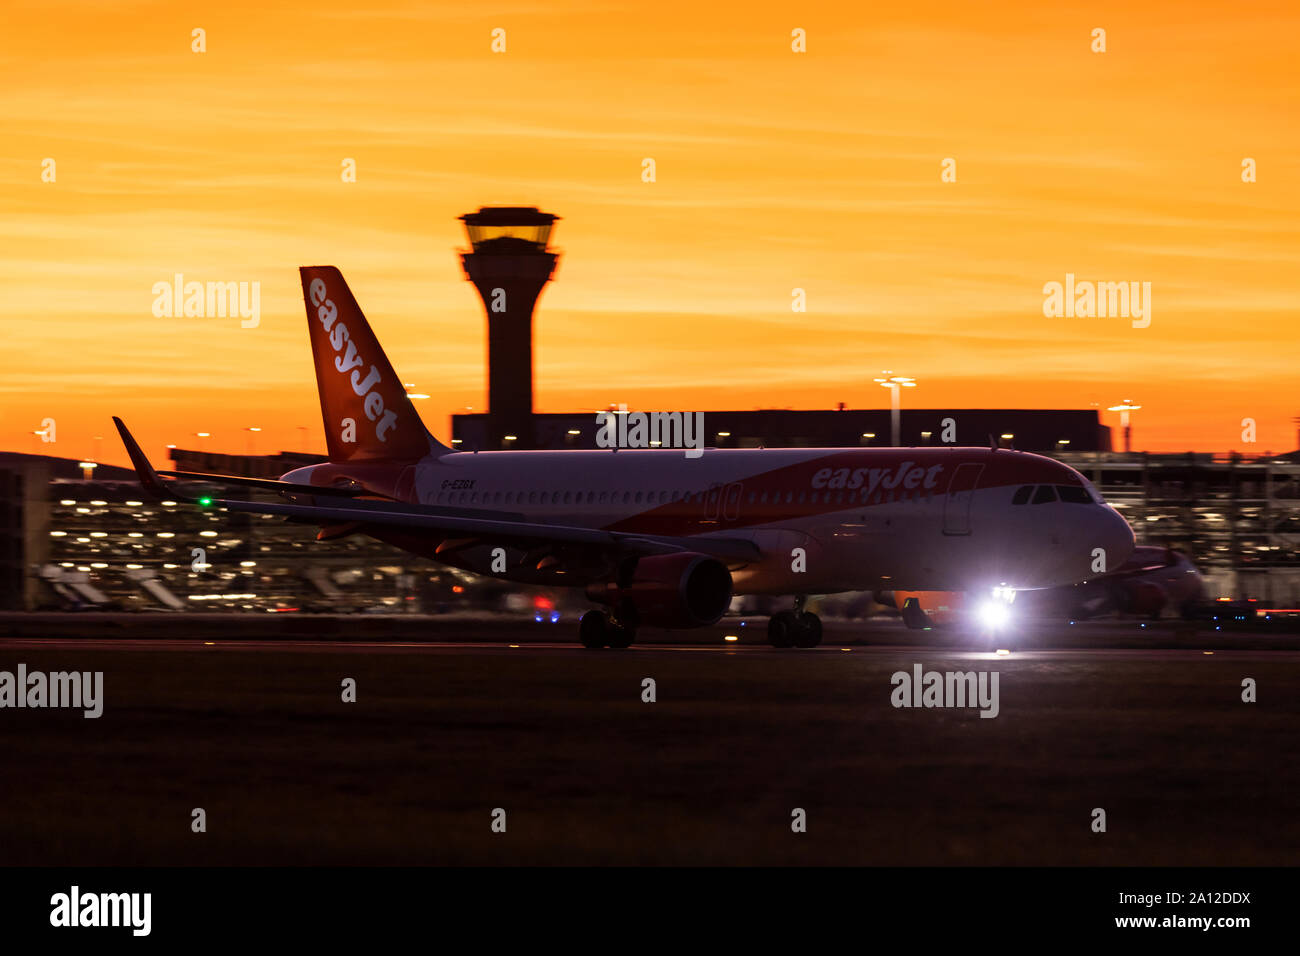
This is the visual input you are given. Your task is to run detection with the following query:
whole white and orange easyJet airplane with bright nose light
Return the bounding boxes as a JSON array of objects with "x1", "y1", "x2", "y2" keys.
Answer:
[{"x1": 113, "y1": 265, "x2": 1134, "y2": 648}]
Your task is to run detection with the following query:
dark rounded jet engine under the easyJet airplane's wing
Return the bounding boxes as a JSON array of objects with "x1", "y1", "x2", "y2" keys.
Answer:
[{"x1": 586, "y1": 551, "x2": 732, "y2": 628}]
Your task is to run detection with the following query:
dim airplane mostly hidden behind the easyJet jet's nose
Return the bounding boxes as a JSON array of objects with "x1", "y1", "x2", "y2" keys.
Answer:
[{"x1": 878, "y1": 545, "x2": 1205, "y2": 630}]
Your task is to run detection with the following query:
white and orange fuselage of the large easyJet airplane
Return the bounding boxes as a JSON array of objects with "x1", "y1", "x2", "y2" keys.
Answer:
[{"x1": 283, "y1": 447, "x2": 1134, "y2": 594}]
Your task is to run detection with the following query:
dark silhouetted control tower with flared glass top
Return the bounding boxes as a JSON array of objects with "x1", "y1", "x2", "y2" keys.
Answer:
[{"x1": 460, "y1": 206, "x2": 559, "y2": 451}]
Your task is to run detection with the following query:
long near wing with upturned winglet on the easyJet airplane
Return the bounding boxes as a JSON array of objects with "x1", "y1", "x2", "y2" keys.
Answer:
[{"x1": 113, "y1": 416, "x2": 762, "y2": 563}]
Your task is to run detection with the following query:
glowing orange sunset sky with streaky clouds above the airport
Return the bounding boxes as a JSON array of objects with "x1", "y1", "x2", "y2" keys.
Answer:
[{"x1": 0, "y1": 0, "x2": 1300, "y2": 463}]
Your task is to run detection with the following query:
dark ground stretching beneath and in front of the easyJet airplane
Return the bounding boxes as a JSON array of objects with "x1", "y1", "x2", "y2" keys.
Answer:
[{"x1": 0, "y1": 626, "x2": 1300, "y2": 865}]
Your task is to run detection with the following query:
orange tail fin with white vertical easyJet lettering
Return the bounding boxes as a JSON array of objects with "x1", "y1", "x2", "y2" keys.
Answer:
[{"x1": 299, "y1": 265, "x2": 451, "y2": 462}]
